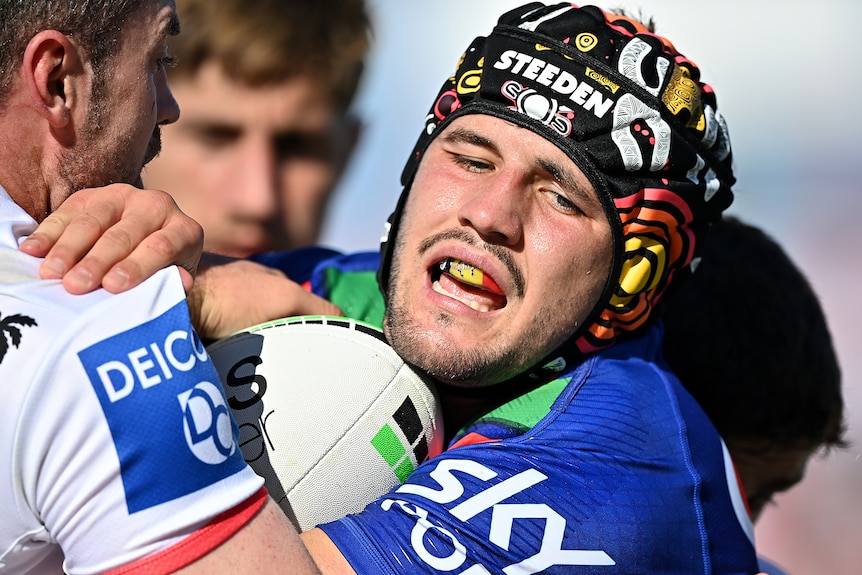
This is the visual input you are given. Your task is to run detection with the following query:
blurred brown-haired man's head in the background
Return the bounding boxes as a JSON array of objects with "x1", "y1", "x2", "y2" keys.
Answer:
[{"x1": 145, "y1": 0, "x2": 370, "y2": 256}]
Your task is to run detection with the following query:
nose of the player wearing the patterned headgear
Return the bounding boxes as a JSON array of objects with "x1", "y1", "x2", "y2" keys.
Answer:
[{"x1": 458, "y1": 170, "x2": 529, "y2": 246}]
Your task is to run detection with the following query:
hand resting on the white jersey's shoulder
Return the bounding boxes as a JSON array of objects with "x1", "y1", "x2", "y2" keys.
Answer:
[{"x1": 21, "y1": 184, "x2": 203, "y2": 293}]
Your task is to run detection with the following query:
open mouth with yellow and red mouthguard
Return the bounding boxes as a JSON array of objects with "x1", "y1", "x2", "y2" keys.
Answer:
[{"x1": 431, "y1": 257, "x2": 507, "y2": 313}]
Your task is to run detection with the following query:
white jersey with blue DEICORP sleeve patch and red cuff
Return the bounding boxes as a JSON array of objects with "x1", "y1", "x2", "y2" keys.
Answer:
[{"x1": 0, "y1": 188, "x2": 265, "y2": 575}]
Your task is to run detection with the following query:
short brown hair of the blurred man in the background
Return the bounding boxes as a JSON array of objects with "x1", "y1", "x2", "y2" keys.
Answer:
[{"x1": 169, "y1": 0, "x2": 371, "y2": 110}]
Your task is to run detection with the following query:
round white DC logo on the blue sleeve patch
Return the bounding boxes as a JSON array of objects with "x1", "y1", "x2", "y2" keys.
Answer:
[{"x1": 177, "y1": 381, "x2": 236, "y2": 465}]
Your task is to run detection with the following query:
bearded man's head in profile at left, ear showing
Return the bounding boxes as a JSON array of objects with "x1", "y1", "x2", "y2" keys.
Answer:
[{"x1": 0, "y1": 0, "x2": 179, "y2": 219}]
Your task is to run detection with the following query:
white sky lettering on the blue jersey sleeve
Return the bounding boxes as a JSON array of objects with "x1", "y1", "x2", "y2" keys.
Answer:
[{"x1": 380, "y1": 456, "x2": 619, "y2": 575}]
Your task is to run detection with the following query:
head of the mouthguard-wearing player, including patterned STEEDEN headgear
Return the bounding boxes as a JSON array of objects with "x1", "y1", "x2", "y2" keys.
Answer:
[{"x1": 380, "y1": 3, "x2": 734, "y2": 386}]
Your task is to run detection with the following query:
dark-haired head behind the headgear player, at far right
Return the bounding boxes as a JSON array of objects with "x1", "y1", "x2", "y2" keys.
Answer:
[{"x1": 661, "y1": 218, "x2": 844, "y2": 517}]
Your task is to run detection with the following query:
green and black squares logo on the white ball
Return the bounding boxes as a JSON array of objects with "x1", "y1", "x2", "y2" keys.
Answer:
[{"x1": 371, "y1": 397, "x2": 428, "y2": 483}]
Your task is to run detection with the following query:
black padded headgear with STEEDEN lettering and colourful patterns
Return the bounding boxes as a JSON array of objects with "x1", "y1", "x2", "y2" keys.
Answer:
[{"x1": 379, "y1": 2, "x2": 735, "y2": 378}]
